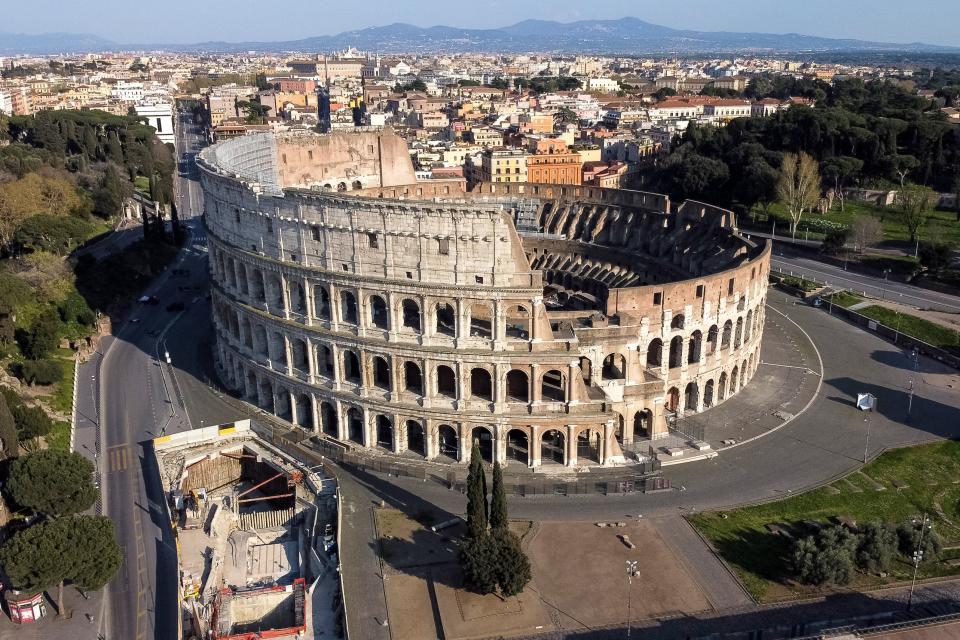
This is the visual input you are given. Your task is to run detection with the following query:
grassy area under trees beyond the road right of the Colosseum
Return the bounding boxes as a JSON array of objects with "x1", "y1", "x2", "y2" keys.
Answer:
[{"x1": 744, "y1": 200, "x2": 960, "y2": 242}]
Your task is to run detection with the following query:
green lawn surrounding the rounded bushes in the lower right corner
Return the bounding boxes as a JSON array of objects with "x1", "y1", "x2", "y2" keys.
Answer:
[{"x1": 690, "y1": 441, "x2": 960, "y2": 602}]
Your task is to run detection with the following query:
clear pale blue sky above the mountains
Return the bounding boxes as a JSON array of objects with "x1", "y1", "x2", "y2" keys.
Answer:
[{"x1": 0, "y1": 0, "x2": 960, "y2": 46}]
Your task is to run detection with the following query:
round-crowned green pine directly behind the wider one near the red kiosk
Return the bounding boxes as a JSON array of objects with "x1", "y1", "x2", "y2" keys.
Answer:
[{"x1": 7, "y1": 449, "x2": 97, "y2": 518}]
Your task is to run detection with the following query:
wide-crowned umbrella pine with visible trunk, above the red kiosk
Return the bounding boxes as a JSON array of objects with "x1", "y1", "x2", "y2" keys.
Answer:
[{"x1": 0, "y1": 516, "x2": 123, "y2": 616}]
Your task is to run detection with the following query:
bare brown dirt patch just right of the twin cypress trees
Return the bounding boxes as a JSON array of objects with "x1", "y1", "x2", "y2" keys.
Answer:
[{"x1": 528, "y1": 522, "x2": 710, "y2": 629}]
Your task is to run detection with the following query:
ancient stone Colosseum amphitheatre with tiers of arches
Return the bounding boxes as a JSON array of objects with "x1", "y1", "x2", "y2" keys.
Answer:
[{"x1": 198, "y1": 129, "x2": 770, "y2": 468}]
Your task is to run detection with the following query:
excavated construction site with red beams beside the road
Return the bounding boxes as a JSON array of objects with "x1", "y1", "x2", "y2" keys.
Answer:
[{"x1": 154, "y1": 420, "x2": 343, "y2": 640}]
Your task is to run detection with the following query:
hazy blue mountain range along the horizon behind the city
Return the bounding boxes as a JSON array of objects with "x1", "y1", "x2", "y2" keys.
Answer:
[{"x1": 0, "y1": 18, "x2": 960, "y2": 54}]
